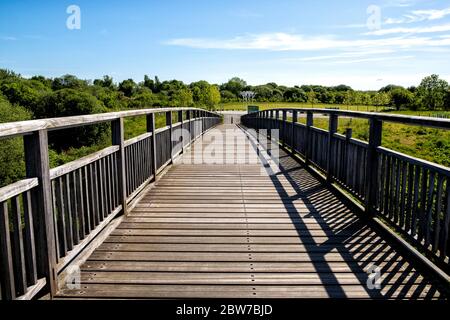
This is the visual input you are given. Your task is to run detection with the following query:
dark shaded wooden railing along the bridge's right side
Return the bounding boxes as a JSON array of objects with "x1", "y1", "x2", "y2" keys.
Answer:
[{"x1": 242, "y1": 109, "x2": 450, "y2": 273}]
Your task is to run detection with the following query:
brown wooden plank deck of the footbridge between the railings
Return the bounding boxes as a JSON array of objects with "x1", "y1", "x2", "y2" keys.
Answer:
[{"x1": 57, "y1": 125, "x2": 442, "y2": 299}]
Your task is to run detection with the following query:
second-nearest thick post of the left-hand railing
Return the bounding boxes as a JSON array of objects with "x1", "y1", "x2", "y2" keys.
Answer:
[{"x1": 111, "y1": 118, "x2": 128, "y2": 215}]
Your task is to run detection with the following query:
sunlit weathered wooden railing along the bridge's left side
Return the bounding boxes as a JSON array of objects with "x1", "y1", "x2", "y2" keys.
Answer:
[{"x1": 0, "y1": 108, "x2": 220, "y2": 300}]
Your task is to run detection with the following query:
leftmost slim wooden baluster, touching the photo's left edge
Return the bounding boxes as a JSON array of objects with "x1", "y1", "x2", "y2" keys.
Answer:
[{"x1": 0, "y1": 202, "x2": 16, "y2": 300}]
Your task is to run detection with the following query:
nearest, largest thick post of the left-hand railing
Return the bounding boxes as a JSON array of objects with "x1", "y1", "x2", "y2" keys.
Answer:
[{"x1": 24, "y1": 130, "x2": 58, "y2": 298}]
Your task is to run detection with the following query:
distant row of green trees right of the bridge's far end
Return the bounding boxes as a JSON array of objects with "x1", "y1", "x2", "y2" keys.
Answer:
[{"x1": 220, "y1": 75, "x2": 450, "y2": 110}]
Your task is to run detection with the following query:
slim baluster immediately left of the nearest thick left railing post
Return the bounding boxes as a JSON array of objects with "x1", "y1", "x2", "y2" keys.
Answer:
[{"x1": 23, "y1": 191, "x2": 37, "y2": 286}]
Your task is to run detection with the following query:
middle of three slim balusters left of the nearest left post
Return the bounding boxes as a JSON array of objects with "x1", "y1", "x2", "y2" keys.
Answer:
[{"x1": 11, "y1": 196, "x2": 27, "y2": 296}]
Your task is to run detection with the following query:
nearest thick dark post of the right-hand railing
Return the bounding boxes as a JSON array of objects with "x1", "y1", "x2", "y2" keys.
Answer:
[{"x1": 365, "y1": 118, "x2": 383, "y2": 215}]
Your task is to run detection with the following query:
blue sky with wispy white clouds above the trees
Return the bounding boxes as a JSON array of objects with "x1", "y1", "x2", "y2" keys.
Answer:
[{"x1": 0, "y1": 0, "x2": 450, "y2": 89}]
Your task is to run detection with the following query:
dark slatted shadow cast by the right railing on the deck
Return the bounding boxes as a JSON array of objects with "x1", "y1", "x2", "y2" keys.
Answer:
[{"x1": 241, "y1": 127, "x2": 438, "y2": 299}]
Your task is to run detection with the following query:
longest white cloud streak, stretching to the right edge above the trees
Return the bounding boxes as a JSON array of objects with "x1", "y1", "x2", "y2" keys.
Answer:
[{"x1": 166, "y1": 33, "x2": 450, "y2": 51}]
